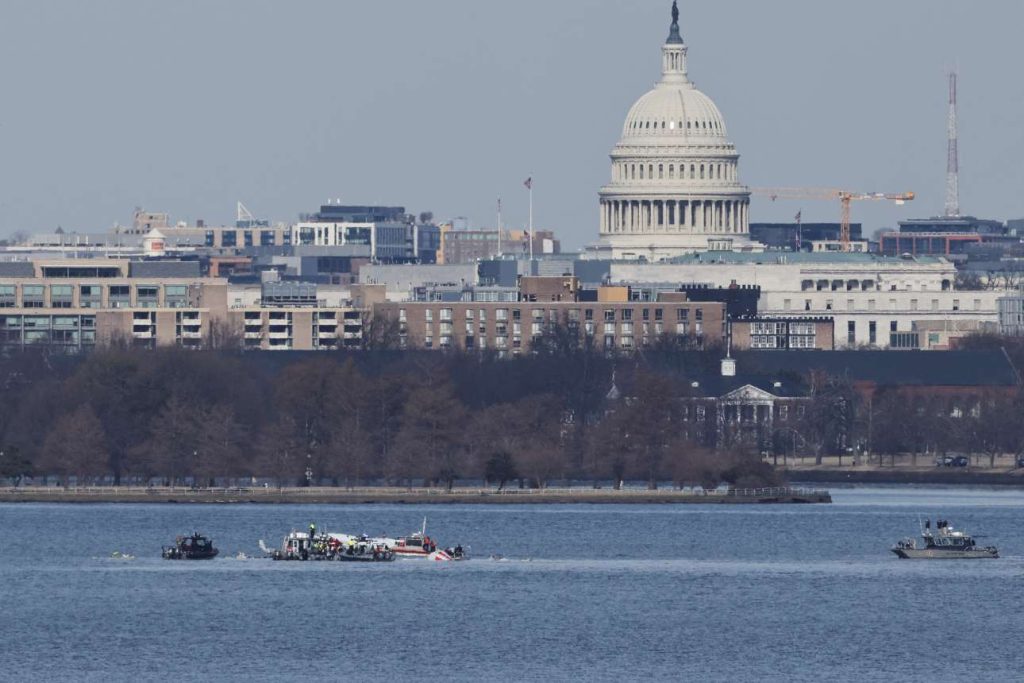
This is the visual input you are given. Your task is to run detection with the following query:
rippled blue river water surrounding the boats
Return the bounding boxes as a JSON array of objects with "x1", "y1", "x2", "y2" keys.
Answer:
[{"x1": 0, "y1": 487, "x2": 1024, "y2": 682}]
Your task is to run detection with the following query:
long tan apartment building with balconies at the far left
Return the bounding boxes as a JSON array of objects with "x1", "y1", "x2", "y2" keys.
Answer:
[{"x1": 0, "y1": 259, "x2": 384, "y2": 352}]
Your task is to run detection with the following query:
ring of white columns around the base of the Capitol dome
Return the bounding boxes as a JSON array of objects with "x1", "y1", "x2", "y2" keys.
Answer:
[{"x1": 601, "y1": 199, "x2": 750, "y2": 234}]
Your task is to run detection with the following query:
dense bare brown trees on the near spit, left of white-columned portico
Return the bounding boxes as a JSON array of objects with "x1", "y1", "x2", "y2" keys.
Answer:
[{"x1": 0, "y1": 348, "x2": 776, "y2": 487}]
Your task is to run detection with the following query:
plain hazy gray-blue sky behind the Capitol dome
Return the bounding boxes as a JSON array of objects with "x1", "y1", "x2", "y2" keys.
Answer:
[{"x1": 0, "y1": 0, "x2": 1024, "y2": 247}]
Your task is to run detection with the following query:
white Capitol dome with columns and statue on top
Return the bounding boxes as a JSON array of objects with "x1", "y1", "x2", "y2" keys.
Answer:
[{"x1": 590, "y1": 2, "x2": 763, "y2": 261}]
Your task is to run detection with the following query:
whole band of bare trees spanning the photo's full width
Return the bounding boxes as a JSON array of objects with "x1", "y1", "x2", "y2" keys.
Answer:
[{"x1": 0, "y1": 338, "x2": 1024, "y2": 486}]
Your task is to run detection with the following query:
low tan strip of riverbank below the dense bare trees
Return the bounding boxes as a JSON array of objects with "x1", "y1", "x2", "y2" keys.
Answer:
[{"x1": 0, "y1": 486, "x2": 831, "y2": 505}]
